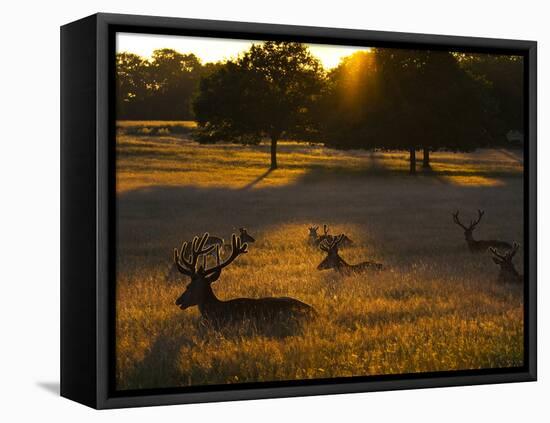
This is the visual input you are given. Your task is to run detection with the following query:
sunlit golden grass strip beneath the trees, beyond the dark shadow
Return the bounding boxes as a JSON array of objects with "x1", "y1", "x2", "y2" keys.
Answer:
[{"x1": 117, "y1": 126, "x2": 523, "y2": 192}]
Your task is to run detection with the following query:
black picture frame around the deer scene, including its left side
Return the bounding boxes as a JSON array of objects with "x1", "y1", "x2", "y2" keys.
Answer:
[{"x1": 61, "y1": 13, "x2": 537, "y2": 409}]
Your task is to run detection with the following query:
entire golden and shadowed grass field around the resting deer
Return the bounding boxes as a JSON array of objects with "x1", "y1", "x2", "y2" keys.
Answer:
[{"x1": 116, "y1": 122, "x2": 523, "y2": 389}]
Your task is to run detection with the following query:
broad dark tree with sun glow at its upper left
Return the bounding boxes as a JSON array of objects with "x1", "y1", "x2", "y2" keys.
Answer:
[{"x1": 322, "y1": 48, "x2": 490, "y2": 173}]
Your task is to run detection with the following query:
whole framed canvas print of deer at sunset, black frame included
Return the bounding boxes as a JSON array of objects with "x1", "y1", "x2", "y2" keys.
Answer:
[{"x1": 61, "y1": 14, "x2": 536, "y2": 408}]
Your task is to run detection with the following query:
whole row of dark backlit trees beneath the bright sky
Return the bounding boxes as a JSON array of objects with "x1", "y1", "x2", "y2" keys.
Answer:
[{"x1": 117, "y1": 42, "x2": 523, "y2": 173}]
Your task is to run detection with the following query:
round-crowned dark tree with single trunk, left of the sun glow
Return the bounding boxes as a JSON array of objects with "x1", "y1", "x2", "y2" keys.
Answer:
[{"x1": 194, "y1": 41, "x2": 323, "y2": 169}]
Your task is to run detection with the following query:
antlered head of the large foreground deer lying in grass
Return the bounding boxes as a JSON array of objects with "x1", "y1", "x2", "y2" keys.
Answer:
[{"x1": 174, "y1": 233, "x2": 248, "y2": 310}]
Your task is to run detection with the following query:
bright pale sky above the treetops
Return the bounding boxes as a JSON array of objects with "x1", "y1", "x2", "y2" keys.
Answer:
[{"x1": 116, "y1": 32, "x2": 374, "y2": 69}]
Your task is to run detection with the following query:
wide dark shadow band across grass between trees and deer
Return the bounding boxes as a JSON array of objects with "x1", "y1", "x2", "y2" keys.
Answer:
[{"x1": 117, "y1": 157, "x2": 521, "y2": 264}]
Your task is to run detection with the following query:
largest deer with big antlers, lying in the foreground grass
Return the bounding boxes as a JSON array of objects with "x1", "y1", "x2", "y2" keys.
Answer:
[{"x1": 174, "y1": 233, "x2": 316, "y2": 327}]
